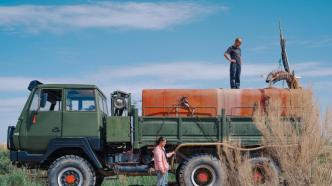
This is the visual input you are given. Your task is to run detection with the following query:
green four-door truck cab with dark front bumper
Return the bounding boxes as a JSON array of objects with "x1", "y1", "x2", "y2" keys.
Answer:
[{"x1": 8, "y1": 81, "x2": 108, "y2": 160}]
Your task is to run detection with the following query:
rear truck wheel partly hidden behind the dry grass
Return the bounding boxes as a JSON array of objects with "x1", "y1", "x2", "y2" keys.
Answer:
[{"x1": 240, "y1": 157, "x2": 281, "y2": 185}]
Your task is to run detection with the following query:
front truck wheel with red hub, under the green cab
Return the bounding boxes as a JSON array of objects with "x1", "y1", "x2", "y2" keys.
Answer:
[{"x1": 48, "y1": 155, "x2": 96, "y2": 186}]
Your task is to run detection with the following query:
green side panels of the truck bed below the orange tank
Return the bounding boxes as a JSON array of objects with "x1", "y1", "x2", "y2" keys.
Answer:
[{"x1": 134, "y1": 111, "x2": 261, "y2": 148}]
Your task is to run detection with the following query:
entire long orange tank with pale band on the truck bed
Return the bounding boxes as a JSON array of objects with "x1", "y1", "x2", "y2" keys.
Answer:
[{"x1": 142, "y1": 88, "x2": 305, "y2": 116}]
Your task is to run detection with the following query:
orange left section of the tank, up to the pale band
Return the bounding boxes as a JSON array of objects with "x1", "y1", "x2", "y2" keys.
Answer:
[{"x1": 142, "y1": 89, "x2": 218, "y2": 116}]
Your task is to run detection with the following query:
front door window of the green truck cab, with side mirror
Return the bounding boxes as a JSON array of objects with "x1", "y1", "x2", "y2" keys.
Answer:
[{"x1": 39, "y1": 89, "x2": 62, "y2": 111}]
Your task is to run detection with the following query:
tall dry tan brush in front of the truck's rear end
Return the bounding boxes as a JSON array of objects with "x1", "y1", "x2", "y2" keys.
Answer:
[{"x1": 219, "y1": 90, "x2": 332, "y2": 186}]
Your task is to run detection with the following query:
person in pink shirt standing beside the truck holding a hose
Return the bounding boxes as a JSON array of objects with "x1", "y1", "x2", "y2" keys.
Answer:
[{"x1": 153, "y1": 137, "x2": 175, "y2": 186}]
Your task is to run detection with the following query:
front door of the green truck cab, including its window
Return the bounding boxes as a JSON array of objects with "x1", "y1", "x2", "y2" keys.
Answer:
[{"x1": 23, "y1": 89, "x2": 62, "y2": 153}]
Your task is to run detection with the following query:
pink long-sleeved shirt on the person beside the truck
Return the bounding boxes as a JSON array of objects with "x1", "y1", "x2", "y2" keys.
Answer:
[{"x1": 153, "y1": 145, "x2": 171, "y2": 171}]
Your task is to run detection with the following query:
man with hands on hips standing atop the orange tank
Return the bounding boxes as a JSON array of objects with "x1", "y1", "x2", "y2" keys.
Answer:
[{"x1": 224, "y1": 37, "x2": 242, "y2": 89}]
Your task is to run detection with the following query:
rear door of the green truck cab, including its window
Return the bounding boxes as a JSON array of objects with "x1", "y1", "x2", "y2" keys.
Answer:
[{"x1": 63, "y1": 88, "x2": 101, "y2": 140}]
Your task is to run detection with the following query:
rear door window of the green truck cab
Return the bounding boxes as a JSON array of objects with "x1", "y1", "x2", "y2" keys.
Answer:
[{"x1": 66, "y1": 89, "x2": 96, "y2": 111}]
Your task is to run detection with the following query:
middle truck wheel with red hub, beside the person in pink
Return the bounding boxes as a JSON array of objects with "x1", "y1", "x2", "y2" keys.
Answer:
[{"x1": 179, "y1": 155, "x2": 226, "y2": 186}]
